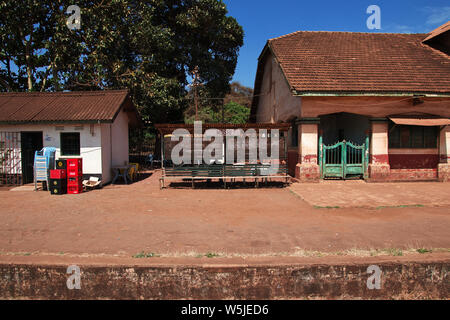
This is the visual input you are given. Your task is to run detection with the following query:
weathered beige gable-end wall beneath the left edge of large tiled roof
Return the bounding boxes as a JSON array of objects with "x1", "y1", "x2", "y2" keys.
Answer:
[{"x1": 256, "y1": 53, "x2": 302, "y2": 123}]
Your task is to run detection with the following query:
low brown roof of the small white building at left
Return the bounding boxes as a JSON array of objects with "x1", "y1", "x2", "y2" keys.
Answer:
[{"x1": 0, "y1": 90, "x2": 135, "y2": 123}]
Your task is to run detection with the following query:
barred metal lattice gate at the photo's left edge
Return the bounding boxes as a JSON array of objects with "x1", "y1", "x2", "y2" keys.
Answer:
[{"x1": 0, "y1": 132, "x2": 23, "y2": 185}]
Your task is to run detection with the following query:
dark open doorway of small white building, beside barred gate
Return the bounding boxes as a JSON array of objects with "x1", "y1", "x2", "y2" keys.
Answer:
[{"x1": 20, "y1": 131, "x2": 44, "y2": 184}]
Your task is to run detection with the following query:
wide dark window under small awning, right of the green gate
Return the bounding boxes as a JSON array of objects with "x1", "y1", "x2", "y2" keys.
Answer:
[{"x1": 389, "y1": 124, "x2": 438, "y2": 149}]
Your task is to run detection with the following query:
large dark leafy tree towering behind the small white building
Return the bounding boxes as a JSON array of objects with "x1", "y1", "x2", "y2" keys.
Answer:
[{"x1": 0, "y1": 0, "x2": 243, "y2": 123}]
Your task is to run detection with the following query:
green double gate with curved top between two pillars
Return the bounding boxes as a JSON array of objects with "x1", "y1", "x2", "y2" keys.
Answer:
[{"x1": 319, "y1": 137, "x2": 369, "y2": 179}]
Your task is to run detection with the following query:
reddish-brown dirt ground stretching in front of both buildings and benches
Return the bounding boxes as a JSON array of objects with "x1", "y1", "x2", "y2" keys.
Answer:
[{"x1": 0, "y1": 172, "x2": 450, "y2": 258}]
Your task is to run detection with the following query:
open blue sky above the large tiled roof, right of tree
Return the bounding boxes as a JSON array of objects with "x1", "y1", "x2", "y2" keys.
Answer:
[{"x1": 223, "y1": 0, "x2": 450, "y2": 87}]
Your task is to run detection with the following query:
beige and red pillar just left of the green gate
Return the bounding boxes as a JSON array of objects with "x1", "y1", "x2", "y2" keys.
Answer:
[{"x1": 295, "y1": 119, "x2": 320, "y2": 182}]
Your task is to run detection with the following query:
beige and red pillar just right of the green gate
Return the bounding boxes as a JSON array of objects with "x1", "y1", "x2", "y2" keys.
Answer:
[{"x1": 369, "y1": 120, "x2": 391, "y2": 181}]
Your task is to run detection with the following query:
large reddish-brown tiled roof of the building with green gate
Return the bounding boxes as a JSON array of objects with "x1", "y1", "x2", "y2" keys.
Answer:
[{"x1": 268, "y1": 31, "x2": 450, "y2": 94}]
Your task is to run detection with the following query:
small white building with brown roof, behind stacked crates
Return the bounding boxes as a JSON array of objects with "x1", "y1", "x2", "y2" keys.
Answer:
[{"x1": 0, "y1": 90, "x2": 141, "y2": 184}]
